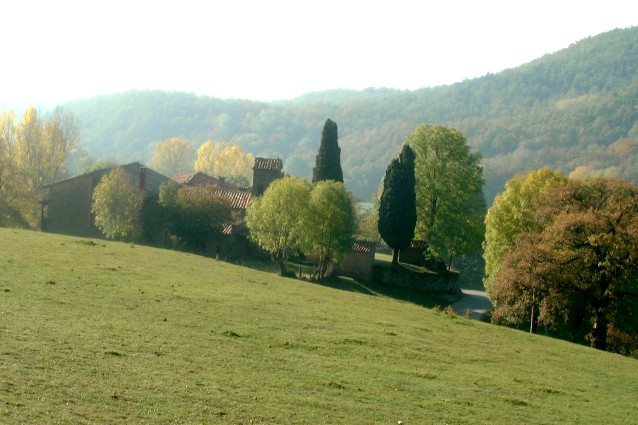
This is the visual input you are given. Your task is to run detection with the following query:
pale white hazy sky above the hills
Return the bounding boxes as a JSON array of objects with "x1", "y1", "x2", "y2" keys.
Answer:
[{"x1": 0, "y1": 0, "x2": 638, "y2": 105}]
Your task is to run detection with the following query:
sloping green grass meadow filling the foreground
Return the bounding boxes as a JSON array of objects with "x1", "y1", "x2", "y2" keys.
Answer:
[{"x1": 0, "y1": 229, "x2": 638, "y2": 425}]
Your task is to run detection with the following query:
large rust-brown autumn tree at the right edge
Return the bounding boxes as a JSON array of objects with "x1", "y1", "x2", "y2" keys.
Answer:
[{"x1": 489, "y1": 178, "x2": 638, "y2": 350}]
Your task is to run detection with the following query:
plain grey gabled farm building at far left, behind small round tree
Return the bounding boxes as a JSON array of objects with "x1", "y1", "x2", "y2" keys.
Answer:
[{"x1": 41, "y1": 162, "x2": 170, "y2": 238}]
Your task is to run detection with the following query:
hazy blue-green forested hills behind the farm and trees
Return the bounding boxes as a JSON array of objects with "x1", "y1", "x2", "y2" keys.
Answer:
[{"x1": 63, "y1": 27, "x2": 638, "y2": 203}]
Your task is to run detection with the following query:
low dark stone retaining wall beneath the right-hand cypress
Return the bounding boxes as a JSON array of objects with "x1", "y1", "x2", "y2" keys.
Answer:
[{"x1": 372, "y1": 264, "x2": 462, "y2": 295}]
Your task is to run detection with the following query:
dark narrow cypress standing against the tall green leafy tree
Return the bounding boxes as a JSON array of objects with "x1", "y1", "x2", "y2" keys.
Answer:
[{"x1": 378, "y1": 145, "x2": 416, "y2": 264}]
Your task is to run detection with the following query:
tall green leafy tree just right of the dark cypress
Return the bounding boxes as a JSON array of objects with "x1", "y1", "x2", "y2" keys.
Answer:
[{"x1": 405, "y1": 125, "x2": 486, "y2": 267}]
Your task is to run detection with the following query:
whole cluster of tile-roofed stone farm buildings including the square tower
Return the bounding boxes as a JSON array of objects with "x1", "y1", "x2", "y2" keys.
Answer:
[{"x1": 41, "y1": 158, "x2": 390, "y2": 280}]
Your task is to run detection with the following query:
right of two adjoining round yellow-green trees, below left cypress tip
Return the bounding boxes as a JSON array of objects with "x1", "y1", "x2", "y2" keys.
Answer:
[{"x1": 301, "y1": 180, "x2": 356, "y2": 279}]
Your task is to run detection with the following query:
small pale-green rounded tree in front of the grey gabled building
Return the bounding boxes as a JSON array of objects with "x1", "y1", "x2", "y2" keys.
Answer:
[{"x1": 92, "y1": 167, "x2": 143, "y2": 239}]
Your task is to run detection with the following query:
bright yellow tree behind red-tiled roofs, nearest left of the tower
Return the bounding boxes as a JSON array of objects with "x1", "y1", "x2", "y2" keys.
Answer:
[{"x1": 195, "y1": 141, "x2": 255, "y2": 186}]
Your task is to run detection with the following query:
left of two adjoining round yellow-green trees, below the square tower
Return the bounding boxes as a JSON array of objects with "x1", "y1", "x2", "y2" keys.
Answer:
[{"x1": 246, "y1": 177, "x2": 310, "y2": 276}]
